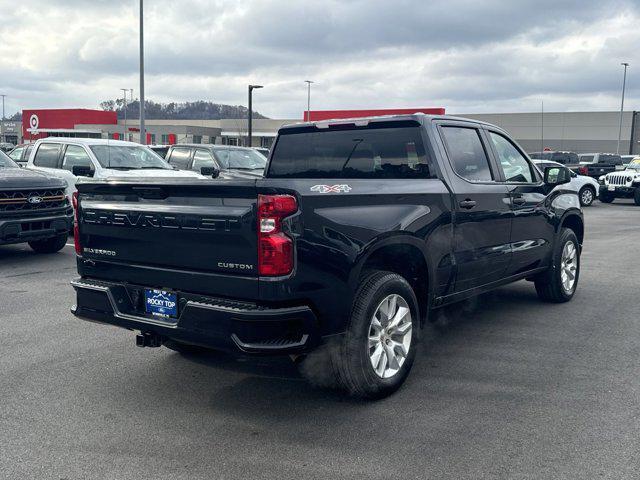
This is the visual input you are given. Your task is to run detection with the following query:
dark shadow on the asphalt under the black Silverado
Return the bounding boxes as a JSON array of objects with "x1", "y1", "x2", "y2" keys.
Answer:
[{"x1": 141, "y1": 282, "x2": 548, "y2": 422}]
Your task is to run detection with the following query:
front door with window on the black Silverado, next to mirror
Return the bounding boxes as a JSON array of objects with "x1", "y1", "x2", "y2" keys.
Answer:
[{"x1": 486, "y1": 128, "x2": 555, "y2": 276}]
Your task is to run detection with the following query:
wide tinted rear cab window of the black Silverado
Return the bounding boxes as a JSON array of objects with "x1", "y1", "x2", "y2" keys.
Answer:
[{"x1": 268, "y1": 120, "x2": 436, "y2": 178}]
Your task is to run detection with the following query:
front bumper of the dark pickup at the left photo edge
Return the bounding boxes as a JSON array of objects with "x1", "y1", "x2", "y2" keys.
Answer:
[{"x1": 0, "y1": 207, "x2": 73, "y2": 245}]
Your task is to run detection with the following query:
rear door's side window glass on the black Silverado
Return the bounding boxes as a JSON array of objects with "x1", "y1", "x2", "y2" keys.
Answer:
[{"x1": 442, "y1": 127, "x2": 493, "y2": 182}]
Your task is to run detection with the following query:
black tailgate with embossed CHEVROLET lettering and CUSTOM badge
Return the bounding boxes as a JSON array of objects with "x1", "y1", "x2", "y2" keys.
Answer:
[{"x1": 78, "y1": 180, "x2": 257, "y2": 277}]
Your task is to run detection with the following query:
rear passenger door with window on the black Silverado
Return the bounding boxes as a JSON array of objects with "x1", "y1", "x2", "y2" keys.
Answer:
[{"x1": 438, "y1": 122, "x2": 511, "y2": 292}]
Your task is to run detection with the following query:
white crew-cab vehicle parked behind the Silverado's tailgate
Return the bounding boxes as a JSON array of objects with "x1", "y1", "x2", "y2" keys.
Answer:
[{"x1": 26, "y1": 137, "x2": 206, "y2": 196}]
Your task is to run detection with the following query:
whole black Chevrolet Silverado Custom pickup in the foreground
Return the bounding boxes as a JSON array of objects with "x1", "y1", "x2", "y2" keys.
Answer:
[{"x1": 72, "y1": 114, "x2": 584, "y2": 398}]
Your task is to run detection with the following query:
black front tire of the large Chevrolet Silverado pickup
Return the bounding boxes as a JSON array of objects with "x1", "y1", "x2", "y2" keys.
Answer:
[{"x1": 535, "y1": 228, "x2": 580, "y2": 303}]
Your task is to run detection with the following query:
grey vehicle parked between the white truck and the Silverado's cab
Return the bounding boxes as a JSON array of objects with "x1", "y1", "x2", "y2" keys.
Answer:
[{"x1": 166, "y1": 144, "x2": 267, "y2": 178}]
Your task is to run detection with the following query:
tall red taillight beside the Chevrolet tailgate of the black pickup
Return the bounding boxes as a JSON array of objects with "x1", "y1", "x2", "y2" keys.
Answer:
[{"x1": 258, "y1": 195, "x2": 298, "y2": 276}]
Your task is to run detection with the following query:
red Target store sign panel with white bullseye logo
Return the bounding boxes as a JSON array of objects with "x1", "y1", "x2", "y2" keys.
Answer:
[{"x1": 22, "y1": 108, "x2": 118, "y2": 140}]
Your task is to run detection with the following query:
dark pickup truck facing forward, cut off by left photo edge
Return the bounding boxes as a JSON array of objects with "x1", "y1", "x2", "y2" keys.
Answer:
[{"x1": 0, "y1": 152, "x2": 73, "y2": 253}]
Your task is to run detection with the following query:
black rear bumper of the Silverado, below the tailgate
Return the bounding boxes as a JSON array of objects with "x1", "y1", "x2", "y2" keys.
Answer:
[{"x1": 71, "y1": 278, "x2": 320, "y2": 354}]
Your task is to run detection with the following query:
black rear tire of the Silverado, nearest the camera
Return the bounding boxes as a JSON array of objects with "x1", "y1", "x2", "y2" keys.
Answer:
[{"x1": 332, "y1": 271, "x2": 420, "y2": 399}]
